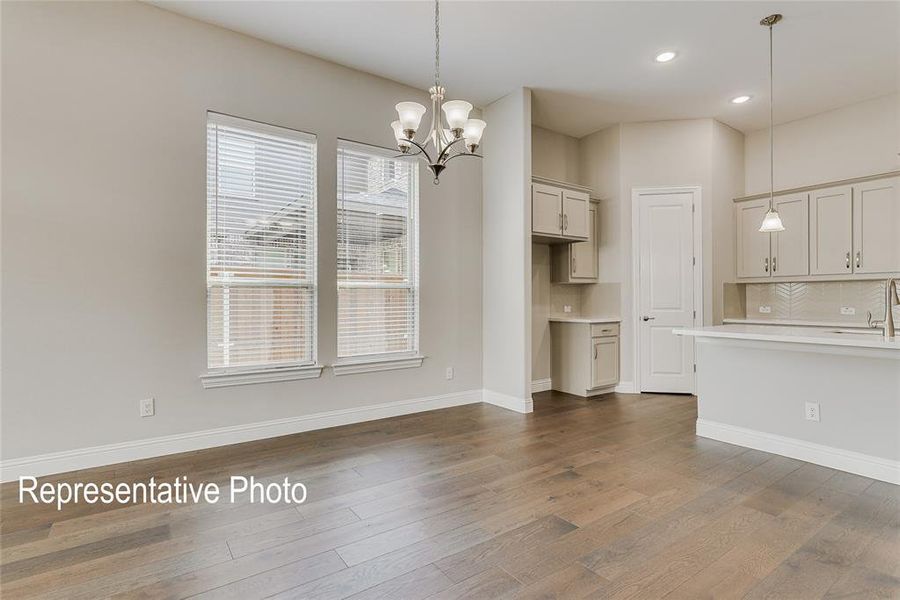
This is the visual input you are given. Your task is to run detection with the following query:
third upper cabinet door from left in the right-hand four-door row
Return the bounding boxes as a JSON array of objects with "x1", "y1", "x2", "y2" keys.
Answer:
[{"x1": 809, "y1": 186, "x2": 853, "y2": 275}]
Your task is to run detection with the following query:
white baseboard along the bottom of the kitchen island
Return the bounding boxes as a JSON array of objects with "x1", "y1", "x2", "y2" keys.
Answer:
[{"x1": 697, "y1": 419, "x2": 900, "y2": 485}]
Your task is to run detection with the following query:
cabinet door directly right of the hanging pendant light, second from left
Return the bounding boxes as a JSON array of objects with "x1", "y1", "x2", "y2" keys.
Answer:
[{"x1": 771, "y1": 193, "x2": 809, "y2": 277}]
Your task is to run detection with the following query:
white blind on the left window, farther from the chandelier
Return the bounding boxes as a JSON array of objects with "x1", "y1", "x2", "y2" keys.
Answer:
[{"x1": 206, "y1": 113, "x2": 316, "y2": 371}]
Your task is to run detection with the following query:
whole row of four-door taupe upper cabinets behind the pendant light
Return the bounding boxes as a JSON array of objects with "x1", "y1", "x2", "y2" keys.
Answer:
[{"x1": 735, "y1": 177, "x2": 900, "y2": 278}]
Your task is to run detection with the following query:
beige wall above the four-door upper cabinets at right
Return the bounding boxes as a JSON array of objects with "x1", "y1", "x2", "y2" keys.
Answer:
[{"x1": 744, "y1": 94, "x2": 900, "y2": 194}]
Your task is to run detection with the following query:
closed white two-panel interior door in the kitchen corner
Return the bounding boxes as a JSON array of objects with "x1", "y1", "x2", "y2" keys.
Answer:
[{"x1": 637, "y1": 191, "x2": 694, "y2": 393}]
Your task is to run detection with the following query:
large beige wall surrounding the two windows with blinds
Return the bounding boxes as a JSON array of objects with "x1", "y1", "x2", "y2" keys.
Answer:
[{"x1": 2, "y1": 2, "x2": 491, "y2": 459}]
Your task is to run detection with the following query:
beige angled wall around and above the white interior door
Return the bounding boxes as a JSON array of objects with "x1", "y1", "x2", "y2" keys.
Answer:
[{"x1": 579, "y1": 119, "x2": 743, "y2": 383}]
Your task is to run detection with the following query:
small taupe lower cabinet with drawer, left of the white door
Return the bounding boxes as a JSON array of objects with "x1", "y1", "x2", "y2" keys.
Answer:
[{"x1": 550, "y1": 317, "x2": 619, "y2": 396}]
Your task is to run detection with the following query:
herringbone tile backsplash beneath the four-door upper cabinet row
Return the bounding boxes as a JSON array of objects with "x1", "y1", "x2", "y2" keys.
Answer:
[{"x1": 746, "y1": 281, "x2": 884, "y2": 325}]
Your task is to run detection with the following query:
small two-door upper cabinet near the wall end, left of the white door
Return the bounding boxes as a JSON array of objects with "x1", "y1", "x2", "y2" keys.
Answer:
[{"x1": 531, "y1": 177, "x2": 590, "y2": 244}]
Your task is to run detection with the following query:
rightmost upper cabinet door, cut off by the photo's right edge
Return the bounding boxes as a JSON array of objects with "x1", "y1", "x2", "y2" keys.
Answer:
[{"x1": 853, "y1": 178, "x2": 900, "y2": 273}]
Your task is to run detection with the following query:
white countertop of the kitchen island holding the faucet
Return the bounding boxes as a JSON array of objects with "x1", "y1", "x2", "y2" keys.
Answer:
[{"x1": 672, "y1": 325, "x2": 900, "y2": 350}]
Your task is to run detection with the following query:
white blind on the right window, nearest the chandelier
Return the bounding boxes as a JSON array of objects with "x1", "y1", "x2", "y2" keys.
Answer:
[{"x1": 337, "y1": 140, "x2": 419, "y2": 358}]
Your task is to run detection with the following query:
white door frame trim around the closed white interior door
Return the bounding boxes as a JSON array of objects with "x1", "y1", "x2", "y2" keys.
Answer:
[{"x1": 631, "y1": 185, "x2": 706, "y2": 394}]
